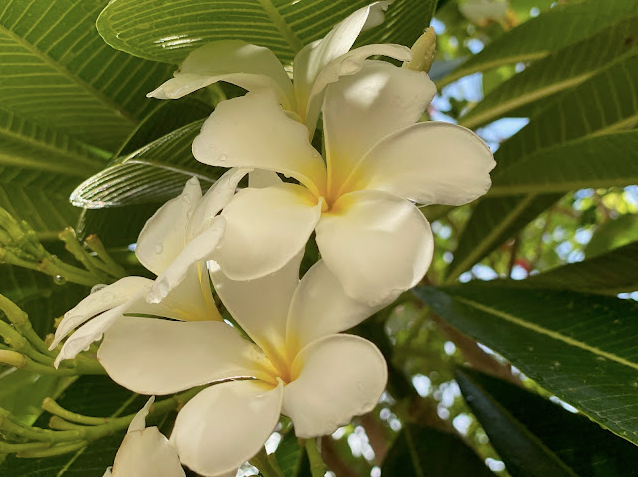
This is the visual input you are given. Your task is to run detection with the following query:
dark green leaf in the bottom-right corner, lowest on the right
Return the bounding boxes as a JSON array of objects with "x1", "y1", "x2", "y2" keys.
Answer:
[{"x1": 456, "y1": 370, "x2": 638, "y2": 476}]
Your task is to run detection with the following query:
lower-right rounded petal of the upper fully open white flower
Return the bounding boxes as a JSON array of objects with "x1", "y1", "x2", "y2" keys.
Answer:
[{"x1": 317, "y1": 191, "x2": 434, "y2": 305}]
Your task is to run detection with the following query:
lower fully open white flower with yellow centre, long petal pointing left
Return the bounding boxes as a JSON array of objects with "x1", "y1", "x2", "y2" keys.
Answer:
[{"x1": 98, "y1": 254, "x2": 387, "y2": 475}]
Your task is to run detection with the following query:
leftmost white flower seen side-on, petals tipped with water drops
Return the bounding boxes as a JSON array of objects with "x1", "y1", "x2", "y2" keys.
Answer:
[{"x1": 49, "y1": 169, "x2": 251, "y2": 367}]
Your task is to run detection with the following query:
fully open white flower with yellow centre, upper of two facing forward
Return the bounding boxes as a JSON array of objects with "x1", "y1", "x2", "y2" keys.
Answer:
[{"x1": 193, "y1": 60, "x2": 495, "y2": 303}]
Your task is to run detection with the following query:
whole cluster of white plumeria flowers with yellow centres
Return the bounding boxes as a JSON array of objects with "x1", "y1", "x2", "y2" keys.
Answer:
[{"x1": 51, "y1": 2, "x2": 494, "y2": 475}]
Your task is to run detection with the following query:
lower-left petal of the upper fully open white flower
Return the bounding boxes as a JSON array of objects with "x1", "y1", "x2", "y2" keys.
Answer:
[{"x1": 214, "y1": 183, "x2": 322, "y2": 280}]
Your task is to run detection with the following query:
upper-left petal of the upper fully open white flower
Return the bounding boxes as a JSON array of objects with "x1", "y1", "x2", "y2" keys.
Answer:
[{"x1": 193, "y1": 93, "x2": 326, "y2": 195}]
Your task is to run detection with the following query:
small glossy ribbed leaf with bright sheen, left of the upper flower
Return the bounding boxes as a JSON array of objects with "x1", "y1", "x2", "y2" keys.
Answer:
[{"x1": 71, "y1": 120, "x2": 225, "y2": 209}]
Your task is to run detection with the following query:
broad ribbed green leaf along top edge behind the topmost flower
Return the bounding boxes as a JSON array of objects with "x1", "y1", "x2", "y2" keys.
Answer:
[{"x1": 97, "y1": 0, "x2": 436, "y2": 63}]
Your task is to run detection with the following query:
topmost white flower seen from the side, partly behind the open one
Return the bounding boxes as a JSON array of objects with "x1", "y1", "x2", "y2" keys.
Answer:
[{"x1": 147, "y1": 1, "x2": 411, "y2": 136}]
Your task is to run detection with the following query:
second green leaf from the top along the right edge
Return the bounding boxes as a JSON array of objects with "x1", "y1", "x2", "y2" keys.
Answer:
[{"x1": 459, "y1": 17, "x2": 638, "y2": 129}]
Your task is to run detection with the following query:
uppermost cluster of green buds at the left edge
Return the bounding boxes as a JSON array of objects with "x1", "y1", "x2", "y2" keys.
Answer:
[{"x1": 0, "y1": 208, "x2": 126, "y2": 286}]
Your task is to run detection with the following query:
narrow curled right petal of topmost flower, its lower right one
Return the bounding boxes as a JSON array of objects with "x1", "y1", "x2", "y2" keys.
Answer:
[{"x1": 306, "y1": 44, "x2": 412, "y2": 131}]
